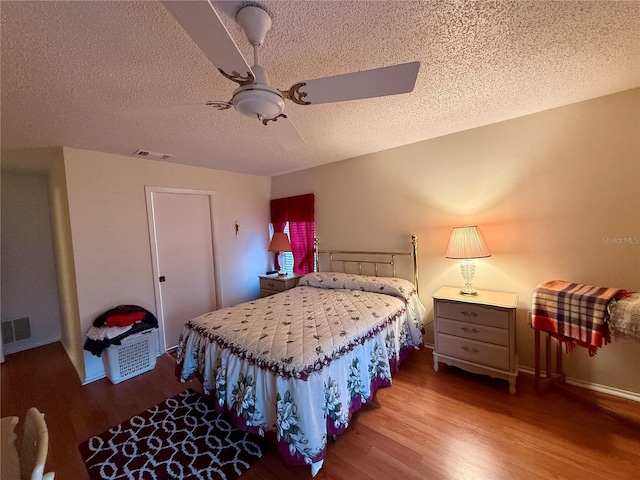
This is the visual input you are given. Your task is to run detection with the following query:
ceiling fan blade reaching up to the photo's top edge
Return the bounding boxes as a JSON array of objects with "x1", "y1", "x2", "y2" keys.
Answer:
[{"x1": 162, "y1": 0, "x2": 254, "y2": 85}]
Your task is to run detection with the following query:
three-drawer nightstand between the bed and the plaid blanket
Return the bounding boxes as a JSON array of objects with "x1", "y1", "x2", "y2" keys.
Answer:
[{"x1": 433, "y1": 287, "x2": 518, "y2": 395}]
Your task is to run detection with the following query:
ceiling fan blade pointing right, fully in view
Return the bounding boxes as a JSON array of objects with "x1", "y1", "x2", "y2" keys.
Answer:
[{"x1": 287, "y1": 62, "x2": 420, "y2": 105}]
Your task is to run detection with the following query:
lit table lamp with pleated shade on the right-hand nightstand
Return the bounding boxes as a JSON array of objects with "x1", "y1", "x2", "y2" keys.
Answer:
[{"x1": 445, "y1": 226, "x2": 491, "y2": 295}]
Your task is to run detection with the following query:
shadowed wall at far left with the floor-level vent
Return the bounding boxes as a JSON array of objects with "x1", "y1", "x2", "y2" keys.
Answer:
[{"x1": 2, "y1": 172, "x2": 61, "y2": 354}]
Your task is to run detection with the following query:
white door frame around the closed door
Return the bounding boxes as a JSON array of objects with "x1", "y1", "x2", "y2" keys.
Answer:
[{"x1": 144, "y1": 185, "x2": 222, "y2": 355}]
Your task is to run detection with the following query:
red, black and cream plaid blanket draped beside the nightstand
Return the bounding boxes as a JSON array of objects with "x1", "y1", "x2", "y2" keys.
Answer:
[{"x1": 531, "y1": 280, "x2": 623, "y2": 356}]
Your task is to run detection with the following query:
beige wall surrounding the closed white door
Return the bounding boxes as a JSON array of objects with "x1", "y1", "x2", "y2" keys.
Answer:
[{"x1": 64, "y1": 148, "x2": 271, "y2": 381}]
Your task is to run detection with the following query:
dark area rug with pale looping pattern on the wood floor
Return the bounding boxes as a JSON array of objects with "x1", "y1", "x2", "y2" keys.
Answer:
[{"x1": 79, "y1": 389, "x2": 266, "y2": 480}]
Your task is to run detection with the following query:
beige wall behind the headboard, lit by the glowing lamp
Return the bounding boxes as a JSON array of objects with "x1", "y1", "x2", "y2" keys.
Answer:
[{"x1": 272, "y1": 89, "x2": 640, "y2": 394}]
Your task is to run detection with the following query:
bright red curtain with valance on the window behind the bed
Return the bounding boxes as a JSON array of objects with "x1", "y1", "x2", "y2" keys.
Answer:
[{"x1": 271, "y1": 193, "x2": 315, "y2": 275}]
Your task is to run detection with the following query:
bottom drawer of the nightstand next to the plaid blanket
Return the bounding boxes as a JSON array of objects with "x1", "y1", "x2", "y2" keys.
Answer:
[{"x1": 438, "y1": 333, "x2": 510, "y2": 370}]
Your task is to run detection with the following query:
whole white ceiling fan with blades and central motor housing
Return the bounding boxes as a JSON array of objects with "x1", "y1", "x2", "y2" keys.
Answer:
[{"x1": 162, "y1": 0, "x2": 420, "y2": 150}]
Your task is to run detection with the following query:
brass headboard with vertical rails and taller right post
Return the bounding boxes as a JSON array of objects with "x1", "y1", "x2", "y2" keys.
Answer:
[{"x1": 315, "y1": 235, "x2": 419, "y2": 293}]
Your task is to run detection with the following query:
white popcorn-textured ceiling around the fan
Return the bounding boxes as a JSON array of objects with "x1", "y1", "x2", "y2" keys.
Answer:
[{"x1": 0, "y1": 1, "x2": 640, "y2": 176}]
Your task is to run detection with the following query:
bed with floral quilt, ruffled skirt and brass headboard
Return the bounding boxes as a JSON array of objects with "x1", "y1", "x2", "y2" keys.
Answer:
[{"x1": 176, "y1": 237, "x2": 425, "y2": 475}]
